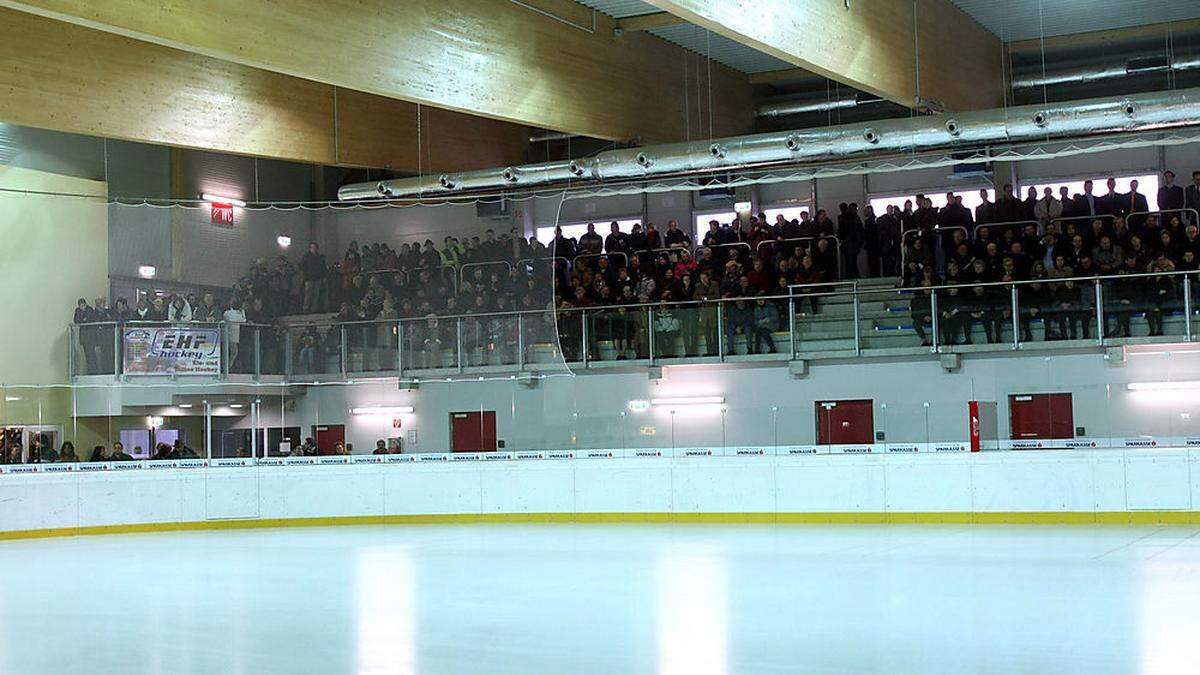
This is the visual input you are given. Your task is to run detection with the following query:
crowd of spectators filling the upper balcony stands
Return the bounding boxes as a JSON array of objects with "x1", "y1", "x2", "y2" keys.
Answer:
[{"x1": 74, "y1": 172, "x2": 1200, "y2": 374}]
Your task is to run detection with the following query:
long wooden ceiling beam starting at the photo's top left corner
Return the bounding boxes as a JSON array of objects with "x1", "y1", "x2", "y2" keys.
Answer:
[{"x1": 0, "y1": 0, "x2": 752, "y2": 142}]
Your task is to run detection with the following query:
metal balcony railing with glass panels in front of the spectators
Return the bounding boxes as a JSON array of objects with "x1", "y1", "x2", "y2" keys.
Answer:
[{"x1": 71, "y1": 265, "x2": 1200, "y2": 382}]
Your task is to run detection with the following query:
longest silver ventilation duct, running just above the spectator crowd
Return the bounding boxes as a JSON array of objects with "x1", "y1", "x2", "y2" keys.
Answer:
[{"x1": 338, "y1": 88, "x2": 1200, "y2": 199}]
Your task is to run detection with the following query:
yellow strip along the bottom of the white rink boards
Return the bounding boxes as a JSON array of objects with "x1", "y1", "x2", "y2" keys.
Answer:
[{"x1": 0, "y1": 510, "x2": 1200, "y2": 539}]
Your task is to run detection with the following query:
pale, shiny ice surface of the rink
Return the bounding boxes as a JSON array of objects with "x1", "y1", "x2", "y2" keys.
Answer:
[{"x1": 0, "y1": 525, "x2": 1200, "y2": 675}]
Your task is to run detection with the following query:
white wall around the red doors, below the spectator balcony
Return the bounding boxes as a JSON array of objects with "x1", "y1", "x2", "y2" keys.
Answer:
[{"x1": 264, "y1": 345, "x2": 1200, "y2": 452}]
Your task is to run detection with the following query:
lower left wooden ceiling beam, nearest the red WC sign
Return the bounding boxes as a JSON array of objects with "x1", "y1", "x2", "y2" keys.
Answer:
[{"x1": 0, "y1": 8, "x2": 529, "y2": 173}]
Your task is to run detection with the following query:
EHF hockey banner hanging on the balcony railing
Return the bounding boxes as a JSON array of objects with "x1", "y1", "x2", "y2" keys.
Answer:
[{"x1": 122, "y1": 327, "x2": 221, "y2": 375}]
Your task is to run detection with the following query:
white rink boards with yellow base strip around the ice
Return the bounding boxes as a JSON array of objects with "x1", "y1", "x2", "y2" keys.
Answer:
[{"x1": 0, "y1": 447, "x2": 1200, "y2": 537}]
